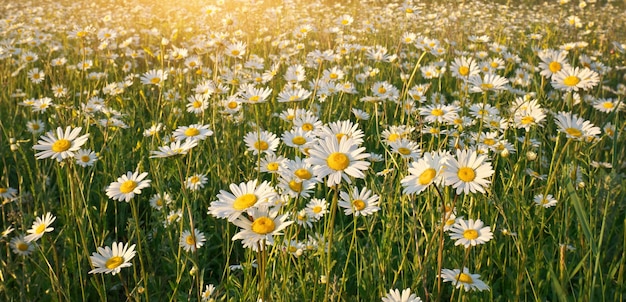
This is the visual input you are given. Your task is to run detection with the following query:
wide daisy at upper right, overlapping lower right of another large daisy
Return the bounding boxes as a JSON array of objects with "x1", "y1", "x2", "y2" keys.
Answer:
[{"x1": 551, "y1": 66, "x2": 600, "y2": 91}]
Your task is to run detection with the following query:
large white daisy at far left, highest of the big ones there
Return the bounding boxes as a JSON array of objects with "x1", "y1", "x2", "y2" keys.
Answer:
[{"x1": 33, "y1": 126, "x2": 89, "y2": 162}]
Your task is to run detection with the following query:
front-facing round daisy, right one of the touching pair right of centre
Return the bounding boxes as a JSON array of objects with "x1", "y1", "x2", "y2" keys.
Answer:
[{"x1": 443, "y1": 150, "x2": 494, "y2": 195}]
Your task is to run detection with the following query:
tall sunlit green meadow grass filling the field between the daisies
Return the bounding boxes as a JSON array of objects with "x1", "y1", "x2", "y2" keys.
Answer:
[{"x1": 0, "y1": 1, "x2": 626, "y2": 301}]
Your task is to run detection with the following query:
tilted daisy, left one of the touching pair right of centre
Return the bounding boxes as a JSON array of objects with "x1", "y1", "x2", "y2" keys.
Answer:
[{"x1": 400, "y1": 152, "x2": 448, "y2": 194}]
